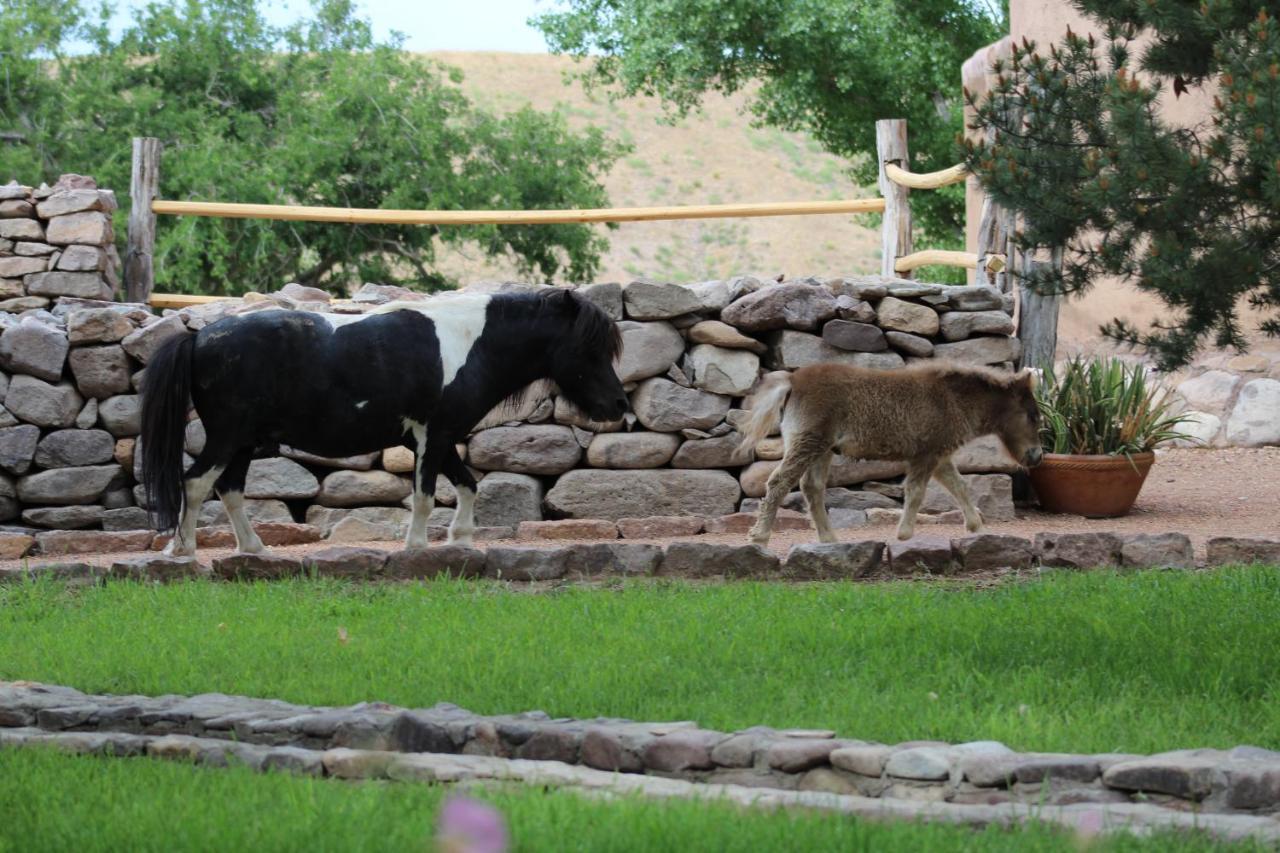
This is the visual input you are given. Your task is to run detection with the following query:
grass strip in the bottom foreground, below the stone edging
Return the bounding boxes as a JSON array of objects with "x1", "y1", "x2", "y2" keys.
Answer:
[{"x1": 0, "y1": 749, "x2": 1263, "y2": 853}]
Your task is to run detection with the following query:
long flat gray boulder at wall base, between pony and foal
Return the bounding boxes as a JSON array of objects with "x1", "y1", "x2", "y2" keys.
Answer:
[{"x1": 547, "y1": 469, "x2": 741, "y2": 520}]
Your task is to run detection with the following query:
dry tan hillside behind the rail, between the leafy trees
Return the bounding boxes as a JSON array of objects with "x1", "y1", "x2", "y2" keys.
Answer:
[{"x1": 429, "y1": 53, "x2": 879, "y2": 282}]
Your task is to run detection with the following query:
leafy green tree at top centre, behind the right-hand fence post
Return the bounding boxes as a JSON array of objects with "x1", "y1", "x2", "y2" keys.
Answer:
[{"x1": 535, "y1": 0, "x2": 1005, "y2": 246}]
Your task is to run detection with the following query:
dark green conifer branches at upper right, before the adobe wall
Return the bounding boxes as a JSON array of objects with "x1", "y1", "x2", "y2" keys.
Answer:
[{"x1": 966, "y1": 0, "x2": 1280, "y2": 369}]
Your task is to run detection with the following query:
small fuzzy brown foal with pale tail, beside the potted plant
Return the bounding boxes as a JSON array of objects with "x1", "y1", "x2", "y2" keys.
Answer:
[{"x1": 739, "y1": 362, "x2": 1043, "y2": 544}]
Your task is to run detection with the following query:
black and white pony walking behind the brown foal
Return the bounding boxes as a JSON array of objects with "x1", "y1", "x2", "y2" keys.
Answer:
[{"x1": 141, "y1": 288, "x2": 627, "y2": 556}]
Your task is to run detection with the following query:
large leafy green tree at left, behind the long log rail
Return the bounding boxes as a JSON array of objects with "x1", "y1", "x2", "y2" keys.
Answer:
[{"x1": 0, "y1": 0, "x2": 622, "y2": 293}]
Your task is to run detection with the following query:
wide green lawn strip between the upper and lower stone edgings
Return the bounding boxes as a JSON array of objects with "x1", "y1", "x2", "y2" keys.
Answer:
[{"x1": 0, "y1": 566, "x2": 1280, "y2": 753}]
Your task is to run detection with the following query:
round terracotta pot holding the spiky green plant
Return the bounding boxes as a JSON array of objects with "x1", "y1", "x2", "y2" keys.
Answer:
[{"x1": 1030, "y1": 452, "x2": 1156, "y2": 519}]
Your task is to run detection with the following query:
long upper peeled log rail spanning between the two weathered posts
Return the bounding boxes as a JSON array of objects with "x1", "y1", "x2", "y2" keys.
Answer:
[{"x1": 151, "y1": 199, "x2": 884, "y2": 225}]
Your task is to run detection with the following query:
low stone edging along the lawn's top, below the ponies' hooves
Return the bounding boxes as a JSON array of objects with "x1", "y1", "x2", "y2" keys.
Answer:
[{"x1": 0, "y1": 523, "x2": 1280, "y2": 583}]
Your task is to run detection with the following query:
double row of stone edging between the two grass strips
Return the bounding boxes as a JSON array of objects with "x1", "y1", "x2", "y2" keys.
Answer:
[{"x1": 0, "y1": 683, "x2": 1280, "y2": 839}]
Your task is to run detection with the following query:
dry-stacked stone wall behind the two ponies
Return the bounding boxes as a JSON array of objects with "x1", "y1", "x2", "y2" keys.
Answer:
[{"x1": 0, "y1": 252, "x2": 1019, "y2": 539}]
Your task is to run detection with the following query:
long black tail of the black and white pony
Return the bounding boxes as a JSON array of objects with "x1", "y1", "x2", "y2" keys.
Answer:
[{"x1": 140, "y1": 334, "x2": 196, "y2": 530}]
